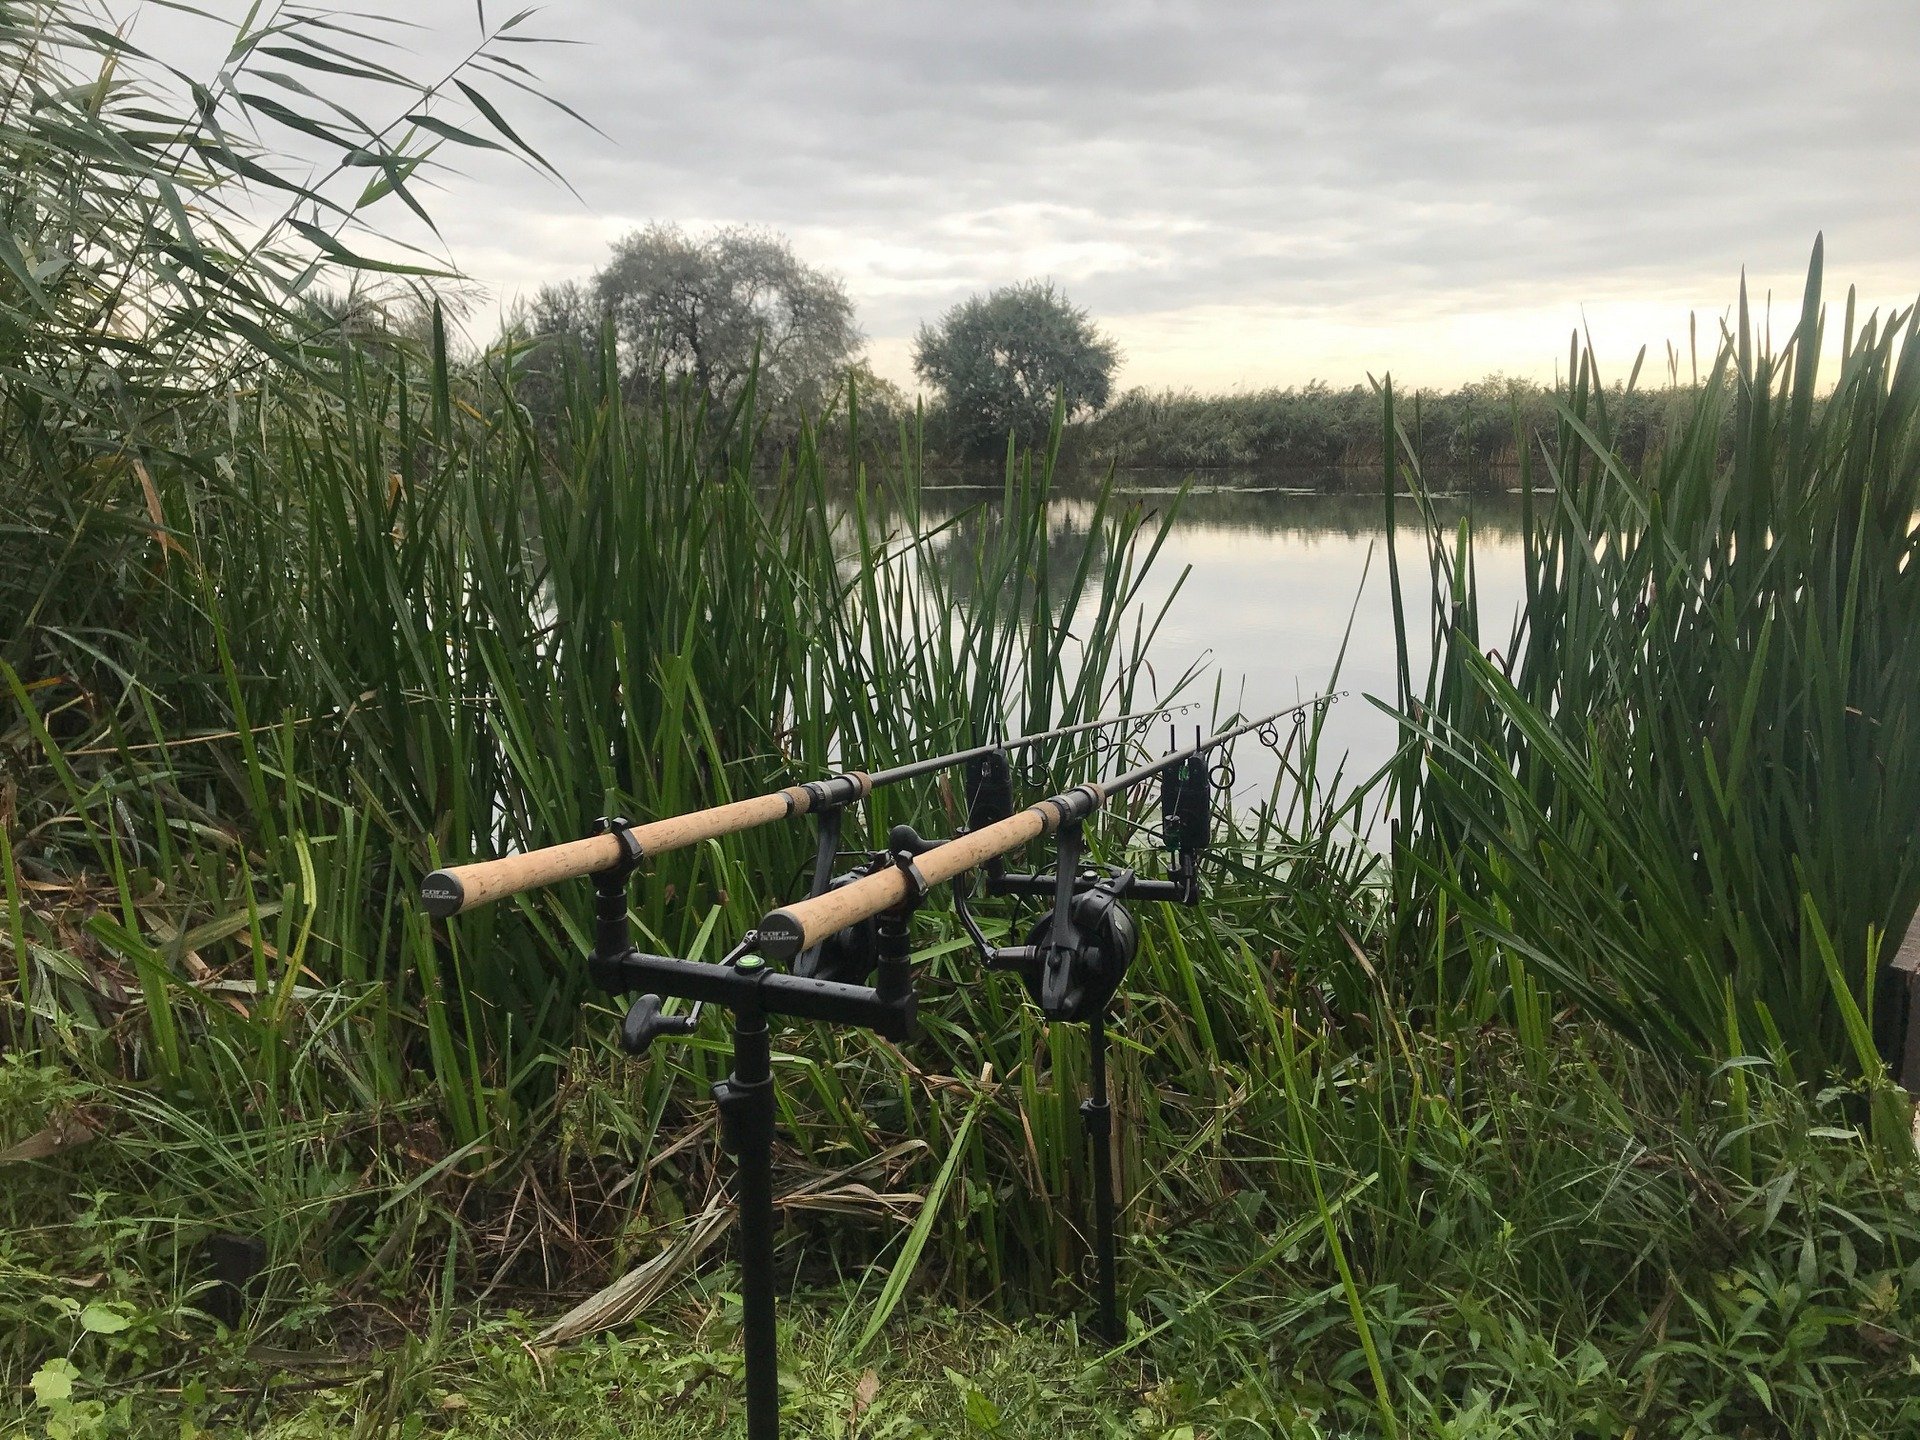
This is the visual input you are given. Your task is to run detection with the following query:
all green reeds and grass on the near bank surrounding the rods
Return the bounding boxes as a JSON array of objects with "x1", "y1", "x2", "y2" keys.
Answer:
[{"x1": 0, "y1": 4, "x2": 1920, "y2": 1440}]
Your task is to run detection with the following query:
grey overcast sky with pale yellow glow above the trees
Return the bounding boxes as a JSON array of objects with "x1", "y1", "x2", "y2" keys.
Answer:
[{"x1": 140, "y1": 0, "x2": 1920, "y2": 390}]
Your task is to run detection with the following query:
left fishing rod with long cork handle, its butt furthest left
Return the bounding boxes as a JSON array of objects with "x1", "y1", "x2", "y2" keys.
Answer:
[{"x1": 420, "y1": 705, "x2": 1188, "y2": 920}]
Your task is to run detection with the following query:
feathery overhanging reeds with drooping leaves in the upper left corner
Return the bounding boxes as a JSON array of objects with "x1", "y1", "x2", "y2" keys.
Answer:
[{"x1": 0, "y1": 0, "x2": 568, "y2": 687}]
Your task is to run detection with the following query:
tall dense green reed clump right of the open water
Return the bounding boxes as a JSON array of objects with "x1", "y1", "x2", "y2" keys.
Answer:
[{"x1": 1388, "y1": 248, "x2": 1920, "y2": 1077}]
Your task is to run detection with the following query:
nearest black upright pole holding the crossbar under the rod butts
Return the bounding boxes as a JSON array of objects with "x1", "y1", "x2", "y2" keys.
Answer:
[{"x1": 714, "y1": 954, "x2": 780, "y2": 1440}]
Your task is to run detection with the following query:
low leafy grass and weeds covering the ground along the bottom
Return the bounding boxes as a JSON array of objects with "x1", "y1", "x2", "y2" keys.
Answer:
[{"x1": 10, "y1": 1021, "x2": 1920, "y2": 1438}]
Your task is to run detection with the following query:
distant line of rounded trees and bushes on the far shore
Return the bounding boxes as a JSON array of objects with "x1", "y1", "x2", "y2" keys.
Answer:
[{"x1": 509, "y1": 225, "x2": 1704, "y2": 480}]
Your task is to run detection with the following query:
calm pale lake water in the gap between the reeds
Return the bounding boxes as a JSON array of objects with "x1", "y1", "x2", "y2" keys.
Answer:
[{"x1": 910, "y1": 472, "x2": 1524, "y2": 821}]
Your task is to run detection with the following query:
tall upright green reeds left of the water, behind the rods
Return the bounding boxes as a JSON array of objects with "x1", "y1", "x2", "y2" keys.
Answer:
[{"x1": 0, "y1": 295, "x2": 1213, "y2": 1297}]
